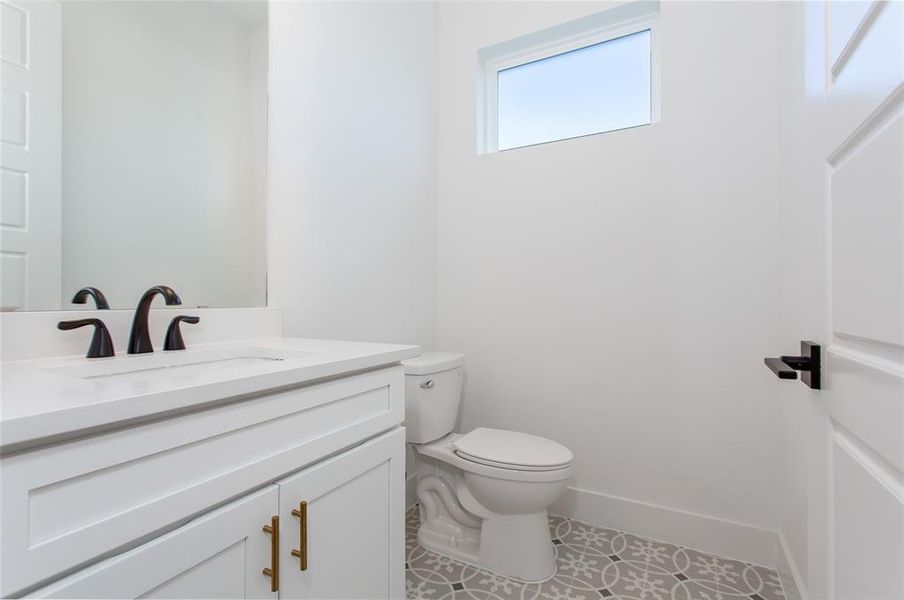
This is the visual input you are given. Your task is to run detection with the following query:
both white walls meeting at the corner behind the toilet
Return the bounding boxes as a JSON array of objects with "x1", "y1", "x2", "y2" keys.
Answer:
[{"x1": 269, "y1": 2, "x2": 785, "y2": 556}]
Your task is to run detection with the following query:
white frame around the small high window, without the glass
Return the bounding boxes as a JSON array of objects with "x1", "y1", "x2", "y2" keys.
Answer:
[{"x1": 477, "y1": 0, "x2": 661, "y2": 154}]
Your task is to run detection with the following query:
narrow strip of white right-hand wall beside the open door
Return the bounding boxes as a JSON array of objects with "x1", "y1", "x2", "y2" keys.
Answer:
[{"x1": 777, "y1": 2, "x2": 828, "y2": 598}]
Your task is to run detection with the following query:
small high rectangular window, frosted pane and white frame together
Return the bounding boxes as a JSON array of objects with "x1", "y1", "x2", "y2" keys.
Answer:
[{"x1": 478, "y1": 2, "x2": 658, "y2": 152}]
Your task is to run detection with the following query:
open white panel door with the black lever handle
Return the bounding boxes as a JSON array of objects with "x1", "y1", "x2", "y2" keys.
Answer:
[{"x1": 792, "y1": 1, "x2": 904, "y2": 600}]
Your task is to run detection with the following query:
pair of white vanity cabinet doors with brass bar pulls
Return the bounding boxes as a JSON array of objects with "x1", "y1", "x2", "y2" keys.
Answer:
[{"x1": 29, "y1": 428, "x2": 405, "y2": 600}]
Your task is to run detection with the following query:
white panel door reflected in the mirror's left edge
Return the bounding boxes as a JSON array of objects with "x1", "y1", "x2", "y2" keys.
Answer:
[{"x1": 0, "y1": 0, "x2": 62, "y2": 310}]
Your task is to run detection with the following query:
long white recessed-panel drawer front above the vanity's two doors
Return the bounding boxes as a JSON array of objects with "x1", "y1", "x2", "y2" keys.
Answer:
[{"x1": 0, "y1": 366, "x2": 404, "y2": 596}]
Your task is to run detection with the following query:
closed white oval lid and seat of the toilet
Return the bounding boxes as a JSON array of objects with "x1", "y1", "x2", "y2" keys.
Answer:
[{"x1": 452, "y1": 427, "x2": 574, "y2": 471}]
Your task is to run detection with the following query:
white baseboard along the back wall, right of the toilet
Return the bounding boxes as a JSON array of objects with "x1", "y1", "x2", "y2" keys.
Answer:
[{"x1": 550, "y1": 487, "x2": 779, "y2": 568}]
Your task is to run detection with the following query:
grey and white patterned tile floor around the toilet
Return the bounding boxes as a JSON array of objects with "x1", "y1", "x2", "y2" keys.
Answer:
[{"x1": 405, "y1": 507, "x2": 785, "y2": 600}]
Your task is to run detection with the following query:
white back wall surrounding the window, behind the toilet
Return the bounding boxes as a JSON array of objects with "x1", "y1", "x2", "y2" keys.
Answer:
[{"x1": 437, "y1": 2, "x2": 793, "y2": 529}]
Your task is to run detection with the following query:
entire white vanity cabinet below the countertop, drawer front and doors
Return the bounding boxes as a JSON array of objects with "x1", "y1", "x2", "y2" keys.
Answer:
[{"x1": 0, "y1": 365, "x2": 405, "y2": 598}]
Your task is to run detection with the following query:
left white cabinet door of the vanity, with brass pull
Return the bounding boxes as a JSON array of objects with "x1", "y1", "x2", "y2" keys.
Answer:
[{"x1": 29, "y1": 485, "x2": 279, "y2": 598}]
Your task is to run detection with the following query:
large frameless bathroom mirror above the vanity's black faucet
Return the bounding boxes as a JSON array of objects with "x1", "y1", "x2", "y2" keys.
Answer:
[{"x1": 0, "y1": 0, "x2": 268, "y2": 310}]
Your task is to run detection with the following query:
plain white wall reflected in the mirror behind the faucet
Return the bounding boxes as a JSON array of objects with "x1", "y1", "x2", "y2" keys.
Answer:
[{"x1": 62, "y1": 2, "x2": 266, "y2": 308}]
